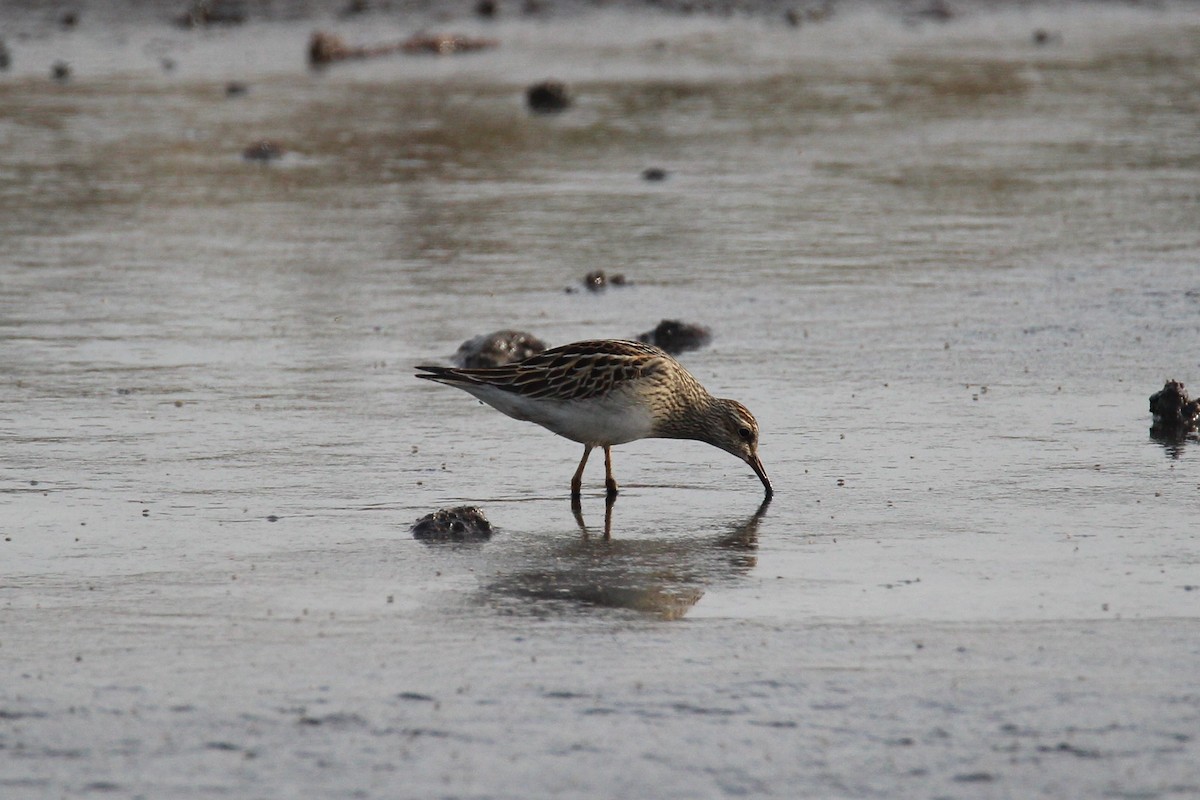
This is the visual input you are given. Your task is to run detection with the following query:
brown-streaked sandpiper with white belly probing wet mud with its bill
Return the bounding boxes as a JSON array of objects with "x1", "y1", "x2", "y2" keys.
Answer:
[{"x1": 416, "y1": 339, "x2": 773, "y2": 499}]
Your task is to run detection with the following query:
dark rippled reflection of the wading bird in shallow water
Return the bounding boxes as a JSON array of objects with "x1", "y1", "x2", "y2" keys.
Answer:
[{"x1": 488, "y1": 498, "x2": 770, "y2": 619}]
